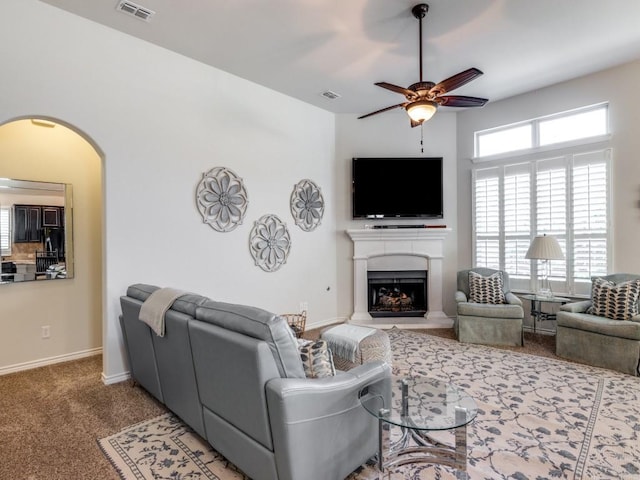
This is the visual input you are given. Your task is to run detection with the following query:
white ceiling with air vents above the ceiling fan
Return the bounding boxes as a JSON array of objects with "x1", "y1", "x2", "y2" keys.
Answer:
[{"x1": 41, "y1": 0, "x2": 640, "y2": 114}]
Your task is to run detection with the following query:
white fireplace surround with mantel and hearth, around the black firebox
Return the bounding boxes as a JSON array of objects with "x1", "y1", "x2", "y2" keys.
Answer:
[{"x1": 347, "y1": 228, "x2": 452, "y2": 328}]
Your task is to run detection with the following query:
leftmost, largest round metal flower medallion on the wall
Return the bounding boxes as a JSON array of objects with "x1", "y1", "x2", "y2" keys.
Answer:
[{"x1": 196, "y1": 167, "x2": 249, "y2": 232}]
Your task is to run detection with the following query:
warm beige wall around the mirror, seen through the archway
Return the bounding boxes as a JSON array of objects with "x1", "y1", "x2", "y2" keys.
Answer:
[{"x1": 0, "y1": 120, "x2": 102, "y2": 372}]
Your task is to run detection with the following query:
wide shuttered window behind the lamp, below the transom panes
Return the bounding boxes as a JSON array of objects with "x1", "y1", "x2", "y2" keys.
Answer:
[{"x1": 473, "y1": 148, "x2": 611, "y2": 294}]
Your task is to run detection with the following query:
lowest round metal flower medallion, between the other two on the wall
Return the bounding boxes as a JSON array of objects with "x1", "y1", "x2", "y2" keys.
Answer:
[{"x1": 249, "y1": 215, "x2": 291, "y2": 272}]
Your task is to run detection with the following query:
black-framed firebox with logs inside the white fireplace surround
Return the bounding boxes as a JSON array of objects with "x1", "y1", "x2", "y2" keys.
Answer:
[{"x1": 367, "y1": 270, "x2": 428, "y2": 317}]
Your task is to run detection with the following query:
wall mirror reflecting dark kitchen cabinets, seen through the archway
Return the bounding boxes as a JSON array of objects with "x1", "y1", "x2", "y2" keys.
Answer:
[{"x1": 0, "y1": 178, "x2": 73, "y2": 285}]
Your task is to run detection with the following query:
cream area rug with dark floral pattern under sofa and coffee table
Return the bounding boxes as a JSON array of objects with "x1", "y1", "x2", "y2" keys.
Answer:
[{"x1": 99, "y1": 329, "x2": 640, "y2": 480}]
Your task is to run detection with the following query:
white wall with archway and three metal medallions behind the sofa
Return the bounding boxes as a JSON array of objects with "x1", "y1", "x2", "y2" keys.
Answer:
[{"x1": 0, "y1": 0, "x2": 337, "y2": 381}]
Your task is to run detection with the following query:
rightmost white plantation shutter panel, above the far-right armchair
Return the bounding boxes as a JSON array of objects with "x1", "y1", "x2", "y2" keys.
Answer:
[{"x1": 572, "y1": 149, "x2": 611, "y2": 281}]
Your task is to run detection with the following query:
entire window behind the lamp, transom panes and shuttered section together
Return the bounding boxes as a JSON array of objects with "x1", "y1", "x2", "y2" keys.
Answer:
[{"x1": 472, "y1": 103, "x2": 611, "y2": 294}]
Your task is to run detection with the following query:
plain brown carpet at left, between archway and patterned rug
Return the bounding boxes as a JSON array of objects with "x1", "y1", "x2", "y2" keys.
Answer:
[{"x1": 0, "y1": 356, "x2": 166, "y2": 480}]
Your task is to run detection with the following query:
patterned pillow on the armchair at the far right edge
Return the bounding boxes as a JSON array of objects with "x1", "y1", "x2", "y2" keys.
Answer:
[{"x1": 587, "y1": 278, "x2": 640, "y2": 320}]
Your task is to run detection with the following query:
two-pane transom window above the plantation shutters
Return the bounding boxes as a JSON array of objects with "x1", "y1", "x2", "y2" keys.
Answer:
[{"x1": 475, "y1": 103, "x2": 609, "y2": 158}]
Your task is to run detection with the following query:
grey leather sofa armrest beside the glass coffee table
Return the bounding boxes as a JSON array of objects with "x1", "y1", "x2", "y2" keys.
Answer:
[{"x1": 265, "y1": 361, "x2": 391, "y2": 480}]
